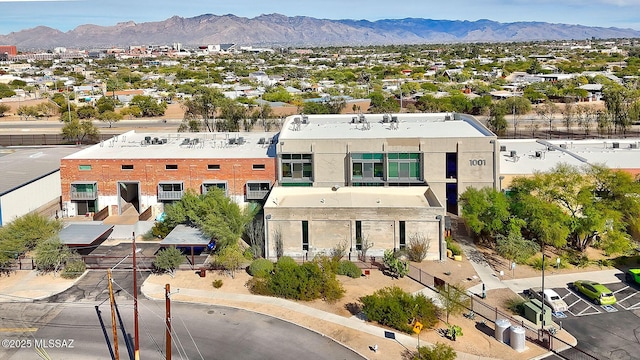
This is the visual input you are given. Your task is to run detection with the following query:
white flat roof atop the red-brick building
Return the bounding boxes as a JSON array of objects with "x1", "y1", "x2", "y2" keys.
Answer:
[{"x1": 66, "y1": 130, "x2": 276, "y2": 159}]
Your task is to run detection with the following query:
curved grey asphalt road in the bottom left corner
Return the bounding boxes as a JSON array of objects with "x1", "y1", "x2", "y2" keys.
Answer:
[{"x1": 0, "y1": 300, "x2": 363, "y2": 360}]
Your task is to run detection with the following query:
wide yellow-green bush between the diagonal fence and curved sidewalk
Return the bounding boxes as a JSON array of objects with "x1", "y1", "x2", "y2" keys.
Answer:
[{"x1": 360, "y1": 286, "x2": 440, "y2": 333}]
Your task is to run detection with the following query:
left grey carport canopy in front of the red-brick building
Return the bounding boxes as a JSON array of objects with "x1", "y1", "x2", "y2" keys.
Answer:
[{"x1": 58, "y1": 222, "x2": 113, "y2": 255}]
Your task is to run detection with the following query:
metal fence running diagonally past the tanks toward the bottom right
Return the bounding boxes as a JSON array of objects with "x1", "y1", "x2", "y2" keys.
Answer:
[{"x1": 408, "y1": 264, "x2": 598, "y2": 360}]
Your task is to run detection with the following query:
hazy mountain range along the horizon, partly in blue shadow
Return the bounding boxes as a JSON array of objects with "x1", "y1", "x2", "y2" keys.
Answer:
[{"x1": 0, "y1": 14, "x2": 640, "y2": 50}]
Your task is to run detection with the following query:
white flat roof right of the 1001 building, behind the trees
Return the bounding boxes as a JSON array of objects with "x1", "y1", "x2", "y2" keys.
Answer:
[{"x1": 498, "y1": 138, "x2": 640, "y2": 175}]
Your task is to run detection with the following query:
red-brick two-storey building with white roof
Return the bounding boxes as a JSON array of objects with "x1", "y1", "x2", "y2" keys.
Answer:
[{"x1": 60, "y1": 131, "x2": 276, "y2": 216}]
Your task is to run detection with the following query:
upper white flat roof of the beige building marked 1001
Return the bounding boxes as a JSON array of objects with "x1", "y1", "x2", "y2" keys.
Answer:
[{"x1": 279, "y1": 113, "x2": 496, "y2": 141}]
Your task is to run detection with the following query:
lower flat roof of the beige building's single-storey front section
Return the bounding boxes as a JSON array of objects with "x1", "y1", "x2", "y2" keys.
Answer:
[{"x1": 264, "y1": 186, "x2": 442, "y2": 210}]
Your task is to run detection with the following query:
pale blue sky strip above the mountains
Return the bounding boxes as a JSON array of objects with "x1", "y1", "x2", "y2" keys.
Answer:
[{"x1": 0, "y1": 0, "x2": 640, "y2": 35}]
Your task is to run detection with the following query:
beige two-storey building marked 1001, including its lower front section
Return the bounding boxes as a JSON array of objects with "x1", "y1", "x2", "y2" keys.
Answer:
[{"x1": 264, "y1": 113, "x2": 499, "y2": 259}]
